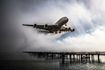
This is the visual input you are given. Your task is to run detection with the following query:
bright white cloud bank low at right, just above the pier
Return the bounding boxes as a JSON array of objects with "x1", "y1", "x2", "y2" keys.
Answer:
[{"x1": 62, "y1": 26, "x2": 105, "y2": 51}]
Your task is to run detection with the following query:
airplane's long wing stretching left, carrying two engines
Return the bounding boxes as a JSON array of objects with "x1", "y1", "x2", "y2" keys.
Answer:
[{"x1": 23, "y1": 24, "x2": 57, "y2": 30}]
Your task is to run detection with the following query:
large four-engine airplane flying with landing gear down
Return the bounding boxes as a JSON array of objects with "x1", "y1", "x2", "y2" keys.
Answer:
[{"x1": 23, "y1": 17, "x2": 75, "y2": 34}]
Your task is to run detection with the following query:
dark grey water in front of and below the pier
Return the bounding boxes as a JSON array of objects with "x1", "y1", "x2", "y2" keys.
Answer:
[{"x1": 0, "y1": 52, "x2": 105, "y2": 70}]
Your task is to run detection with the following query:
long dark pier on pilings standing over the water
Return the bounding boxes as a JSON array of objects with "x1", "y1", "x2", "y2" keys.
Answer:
[{"x1": 23, "y1": 51, "x2": 105, "y2": 64}]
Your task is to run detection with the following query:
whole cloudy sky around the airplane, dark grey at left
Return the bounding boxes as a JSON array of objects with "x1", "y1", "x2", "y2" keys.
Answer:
[{"x1": 0, "y1": 0, "x2": 105, "y2": 60}]
